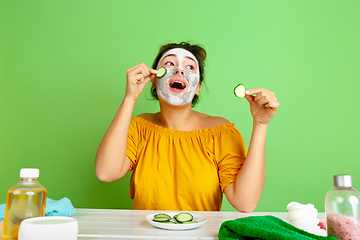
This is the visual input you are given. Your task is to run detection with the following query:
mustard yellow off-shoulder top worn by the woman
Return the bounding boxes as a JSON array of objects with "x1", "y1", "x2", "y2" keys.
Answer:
[{"x1": 127, "y1": 117, "x2": 246, "y2": 211}]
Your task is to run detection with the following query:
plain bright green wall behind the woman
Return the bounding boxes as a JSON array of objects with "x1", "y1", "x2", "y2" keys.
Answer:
[{"x1": 0, "y1": 0, "x2": 360, "y2": 211}]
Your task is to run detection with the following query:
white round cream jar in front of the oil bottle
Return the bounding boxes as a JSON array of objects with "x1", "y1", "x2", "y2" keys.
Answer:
[{"x1": 18, "y1": 217, "x2": 78, "y2": 240}]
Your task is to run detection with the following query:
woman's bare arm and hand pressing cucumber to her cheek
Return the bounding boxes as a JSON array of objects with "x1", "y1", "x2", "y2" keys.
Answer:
[{"x1": 95, "y1": 63, "x2": 157, "y2": 182}]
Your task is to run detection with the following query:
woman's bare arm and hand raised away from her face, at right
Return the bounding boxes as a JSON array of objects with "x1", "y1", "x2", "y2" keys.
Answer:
[{"x1": 225, "y1": 89, "x2": 279, "y2": 212}]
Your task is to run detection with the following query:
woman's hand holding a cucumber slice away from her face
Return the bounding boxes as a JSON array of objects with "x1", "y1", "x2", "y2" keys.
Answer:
[{"x1": 245, "y1": 88, "x2": 280, "y2": 124}]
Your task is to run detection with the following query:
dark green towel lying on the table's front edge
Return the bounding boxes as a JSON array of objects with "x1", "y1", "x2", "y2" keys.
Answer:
[{"x1": 218, "y1": 216, "x2": 337, "y2": 240}]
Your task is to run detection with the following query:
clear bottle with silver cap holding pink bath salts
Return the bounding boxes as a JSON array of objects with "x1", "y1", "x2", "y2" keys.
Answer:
[{"x1": 325, "y1": 175, "x2": 360, "y2": 240}]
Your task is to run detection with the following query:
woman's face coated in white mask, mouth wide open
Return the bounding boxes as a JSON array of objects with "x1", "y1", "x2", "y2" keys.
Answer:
[{"x1": 155, "y1": 48, "x2": 200, "y2": 106}]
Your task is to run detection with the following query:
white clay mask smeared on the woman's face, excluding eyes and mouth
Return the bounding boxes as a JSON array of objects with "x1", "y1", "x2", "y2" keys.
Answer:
[{"x1": 155, "y1": 48, "x2": 200, "y2": 106}]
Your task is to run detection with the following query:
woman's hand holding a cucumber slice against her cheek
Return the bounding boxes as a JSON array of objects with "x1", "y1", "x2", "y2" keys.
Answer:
[{"x1": 125, "y1": 63, "x2": 157, "y2": 101}]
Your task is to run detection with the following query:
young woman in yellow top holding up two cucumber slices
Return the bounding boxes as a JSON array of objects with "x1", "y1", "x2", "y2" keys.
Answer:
[{"x1": 95, "y1": 42, "x2": 279, "y2": 212}]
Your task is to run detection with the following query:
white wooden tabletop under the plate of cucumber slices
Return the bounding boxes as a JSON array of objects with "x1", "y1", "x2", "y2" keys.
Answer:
[{"x1": 72, "y1": 209, "x2": 324, "y2": 240}]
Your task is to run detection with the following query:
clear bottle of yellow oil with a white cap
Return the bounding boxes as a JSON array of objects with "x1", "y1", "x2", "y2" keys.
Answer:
[{"x1": 2, "y1": 168, "x2": 47, "y2": 240}]
